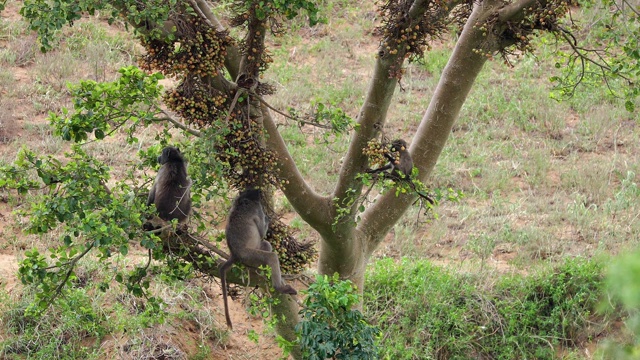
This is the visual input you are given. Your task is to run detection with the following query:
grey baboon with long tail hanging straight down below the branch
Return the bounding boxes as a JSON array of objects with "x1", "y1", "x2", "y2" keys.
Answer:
[{"x1": 220, "y1": 189, "x2": 297, "y2": 329}]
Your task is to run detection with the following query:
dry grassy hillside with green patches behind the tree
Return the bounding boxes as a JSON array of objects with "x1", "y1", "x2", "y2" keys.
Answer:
[{"x1": 0, "y1": 0, "x2": 640, "y2": 359}]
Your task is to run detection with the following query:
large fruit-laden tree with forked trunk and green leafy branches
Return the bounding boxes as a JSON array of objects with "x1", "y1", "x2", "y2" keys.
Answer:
[{"x1": 0, "y1": 0, "x2": 640, "y2": 356}]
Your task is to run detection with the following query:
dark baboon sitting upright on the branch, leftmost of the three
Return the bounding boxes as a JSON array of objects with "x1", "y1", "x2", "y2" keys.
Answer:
[{"x1": 147, "y1": 146, "x2": 191, "y2": 223}]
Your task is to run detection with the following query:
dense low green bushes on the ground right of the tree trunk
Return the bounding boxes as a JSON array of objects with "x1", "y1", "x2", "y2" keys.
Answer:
[{"x1": 365, "y1": 259, "x2": 603, "y2": 359}]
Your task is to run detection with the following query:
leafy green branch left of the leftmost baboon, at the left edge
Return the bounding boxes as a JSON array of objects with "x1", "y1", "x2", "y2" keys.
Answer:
[{"x1": 0, "y1": 145, "x2": 180, "y2": 311}]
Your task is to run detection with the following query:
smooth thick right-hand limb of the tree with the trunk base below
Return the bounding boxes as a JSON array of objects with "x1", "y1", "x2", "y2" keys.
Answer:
[{"x1": 319, "y1": 3, "x2": 491, "y2": 292}]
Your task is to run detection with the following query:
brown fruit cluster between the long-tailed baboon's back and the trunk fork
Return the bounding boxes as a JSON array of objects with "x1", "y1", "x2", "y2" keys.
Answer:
[{"x1": 267, "y1": 220, "x2": 318, "y2": 274}]
